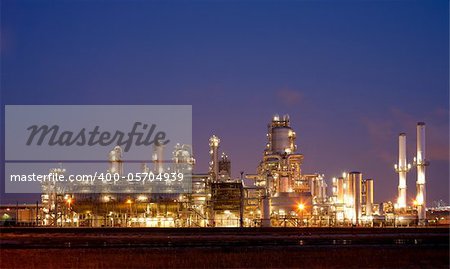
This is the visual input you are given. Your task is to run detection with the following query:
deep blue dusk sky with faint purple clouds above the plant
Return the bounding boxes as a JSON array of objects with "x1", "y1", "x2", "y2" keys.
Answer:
[{"x1": 1, "y1": 0, "x2": 449, "y2": 204}]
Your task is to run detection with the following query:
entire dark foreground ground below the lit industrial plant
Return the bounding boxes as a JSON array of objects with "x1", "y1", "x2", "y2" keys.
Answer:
[{"x1": 0, "y1": 228, "x2": 449, "y2": 268}]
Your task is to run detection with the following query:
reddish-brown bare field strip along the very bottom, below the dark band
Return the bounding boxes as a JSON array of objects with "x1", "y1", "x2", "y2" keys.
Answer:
[{"x1": 0, "y1": 246, "x2": 449, "y2": 269}]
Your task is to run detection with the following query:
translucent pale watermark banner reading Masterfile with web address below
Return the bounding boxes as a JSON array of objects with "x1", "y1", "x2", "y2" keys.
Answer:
[{"x1": 5, "y1": 105, "x2": 194, "y2": 193}]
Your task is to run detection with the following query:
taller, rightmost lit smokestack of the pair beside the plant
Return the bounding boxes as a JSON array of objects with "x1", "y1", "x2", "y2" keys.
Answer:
[{"x1": 415, "y1": 122, "x2": 428, "y2": 225}]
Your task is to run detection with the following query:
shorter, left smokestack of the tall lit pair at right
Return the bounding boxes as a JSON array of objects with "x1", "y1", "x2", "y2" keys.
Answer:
[{"x1": 395, "y1": 133, "x2": 411, "y2": 209}]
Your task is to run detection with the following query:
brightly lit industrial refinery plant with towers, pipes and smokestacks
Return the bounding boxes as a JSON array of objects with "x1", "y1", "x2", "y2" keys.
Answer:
[{"x1": 2, "y1": 115, "x2": 442, "y2": 227}]
